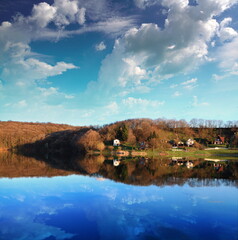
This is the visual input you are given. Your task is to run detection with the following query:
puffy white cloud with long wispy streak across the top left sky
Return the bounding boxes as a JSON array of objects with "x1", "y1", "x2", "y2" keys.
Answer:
[{"x1": 0, "y1": 0, "x2": 135, "y2": 48}]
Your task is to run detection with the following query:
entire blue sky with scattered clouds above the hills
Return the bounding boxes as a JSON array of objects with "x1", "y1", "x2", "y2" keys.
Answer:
[{"x1": 0, "y1": 0, "x2": 238, "y2": 125}]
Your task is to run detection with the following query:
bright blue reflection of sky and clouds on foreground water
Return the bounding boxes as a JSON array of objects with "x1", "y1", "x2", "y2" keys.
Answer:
[{"x1": 0, "y1": 175, "x2": 238, "y2": 240}]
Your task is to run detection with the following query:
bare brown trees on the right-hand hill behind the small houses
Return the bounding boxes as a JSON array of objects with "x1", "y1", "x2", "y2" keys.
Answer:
[{"x1": 99, "y1": 119, "x2": 238, "y2": 148}]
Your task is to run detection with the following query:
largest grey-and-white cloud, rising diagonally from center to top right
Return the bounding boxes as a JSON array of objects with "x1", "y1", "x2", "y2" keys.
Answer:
[{"x1": 83, "y1": 0, "x2": 237, "y2": 104}]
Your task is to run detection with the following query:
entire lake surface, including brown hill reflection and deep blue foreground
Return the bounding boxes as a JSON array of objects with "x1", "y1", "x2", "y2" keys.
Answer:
[{"x1": 0, "y1": 153, "x2": 238, "y2": 240}]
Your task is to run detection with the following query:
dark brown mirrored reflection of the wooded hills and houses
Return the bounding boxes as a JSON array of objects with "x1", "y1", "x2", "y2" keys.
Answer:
[{"x1": 0, "y1": 153, "x2": 238, "y2": 186}]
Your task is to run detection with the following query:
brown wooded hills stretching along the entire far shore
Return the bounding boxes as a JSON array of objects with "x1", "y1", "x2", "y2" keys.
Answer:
[{"x1": 0, "y1": 119, "x2": 238, "y2": 152}]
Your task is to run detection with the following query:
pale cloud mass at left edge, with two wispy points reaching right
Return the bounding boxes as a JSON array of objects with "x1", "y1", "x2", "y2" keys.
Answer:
[{"x1": 0, "y1": 32, "x2": 77, "y2": 116}]
